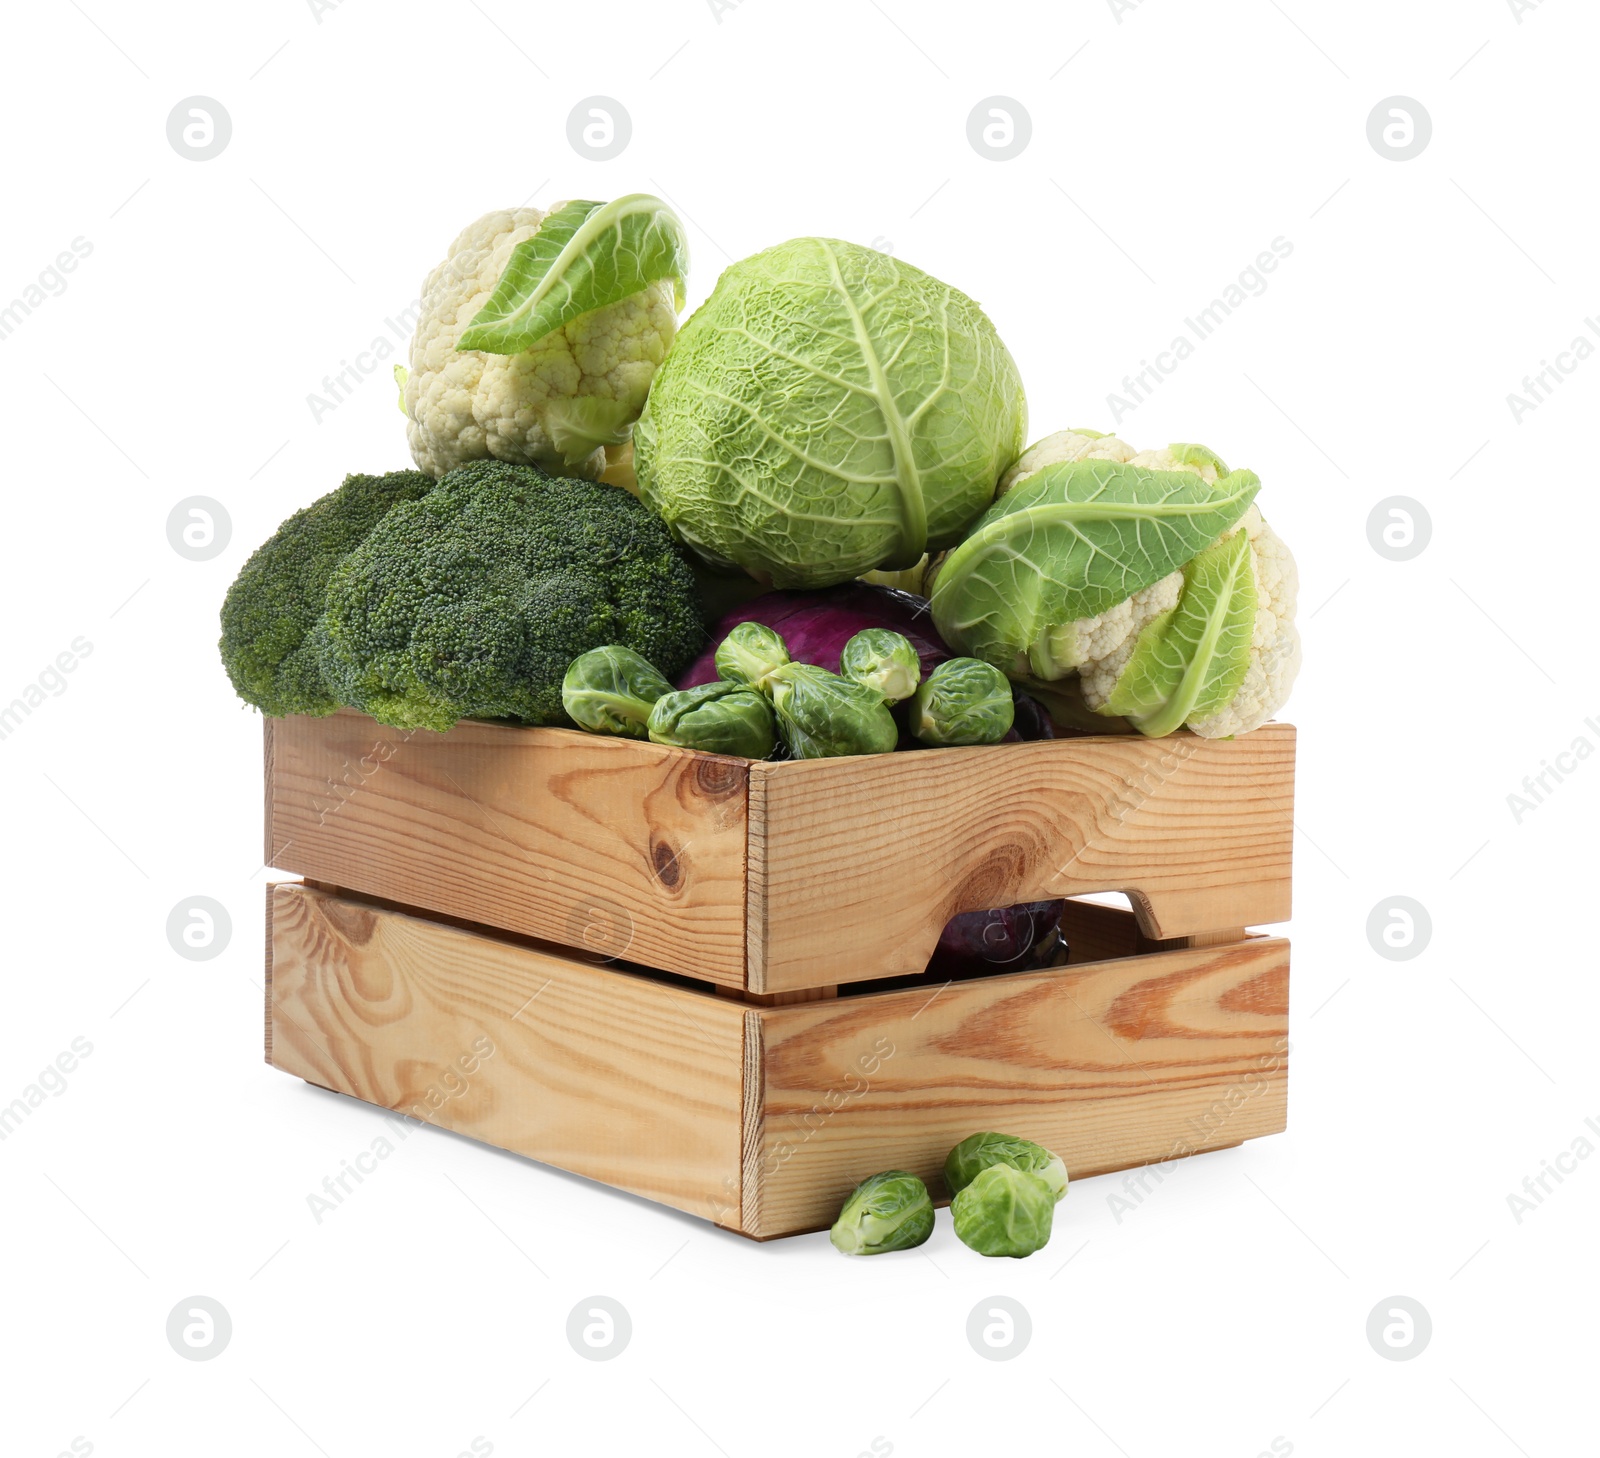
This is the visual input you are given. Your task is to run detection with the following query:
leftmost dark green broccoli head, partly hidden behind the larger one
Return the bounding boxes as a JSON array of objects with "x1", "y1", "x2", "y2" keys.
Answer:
[{"x1": 218, "y1": 471, "x2": 434, "y2": 715}]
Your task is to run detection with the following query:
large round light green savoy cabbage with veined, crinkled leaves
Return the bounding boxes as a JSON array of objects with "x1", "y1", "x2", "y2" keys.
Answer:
[{"x1": 634, "y1": 238, "x2": 1027, "y2": 587}]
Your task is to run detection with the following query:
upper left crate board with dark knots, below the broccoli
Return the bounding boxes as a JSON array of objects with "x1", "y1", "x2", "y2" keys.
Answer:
[{"x1": 266, "y1": 712, "x2": 747, "y2": 986}]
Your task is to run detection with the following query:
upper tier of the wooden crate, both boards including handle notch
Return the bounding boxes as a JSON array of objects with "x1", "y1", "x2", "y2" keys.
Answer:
[{"x1": 266, "y1": 712, "x2": 1294, "y2": 995}]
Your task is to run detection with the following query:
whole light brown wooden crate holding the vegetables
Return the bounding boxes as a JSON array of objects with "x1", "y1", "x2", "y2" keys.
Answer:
[{"x1": 266, "y1": 714, "x2": 1294, "y2": 1239}]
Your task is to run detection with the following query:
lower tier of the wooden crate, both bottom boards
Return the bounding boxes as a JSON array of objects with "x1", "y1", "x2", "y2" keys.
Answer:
[{"x1": 267, "y1": 883, "x2": 1288, "y2": 1239}]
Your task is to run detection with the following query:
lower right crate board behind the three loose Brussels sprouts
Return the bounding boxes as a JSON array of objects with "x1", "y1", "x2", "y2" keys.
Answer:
[{"x1": 746, "y1": 938, "x2": 1288, "y2": 1237}]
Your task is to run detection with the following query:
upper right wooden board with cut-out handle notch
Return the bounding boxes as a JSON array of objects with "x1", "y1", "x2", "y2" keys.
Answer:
[{"x1": 749, "y1": 725, "x2": 1294, "y2": 992}]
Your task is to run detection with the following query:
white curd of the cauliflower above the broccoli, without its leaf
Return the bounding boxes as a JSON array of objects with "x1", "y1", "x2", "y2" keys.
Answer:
[{"x1": 405, "y1": 208, "x2": 677, "y2": 477}]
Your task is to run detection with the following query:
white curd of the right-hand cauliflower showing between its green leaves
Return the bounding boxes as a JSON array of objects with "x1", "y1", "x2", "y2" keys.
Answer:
[{"x1": 997, "y1": 429, "x2": 1301, "y2": 739}]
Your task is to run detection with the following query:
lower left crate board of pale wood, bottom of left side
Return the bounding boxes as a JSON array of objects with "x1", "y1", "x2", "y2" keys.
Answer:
[{"x1": 269, "y1": 883, "x2": 749, "y2": 1228}]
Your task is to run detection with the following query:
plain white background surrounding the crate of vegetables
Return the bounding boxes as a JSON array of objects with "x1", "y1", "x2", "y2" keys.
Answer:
[{"x1": 0, "y1": 0, "x2": 1600, "y2": 1458}]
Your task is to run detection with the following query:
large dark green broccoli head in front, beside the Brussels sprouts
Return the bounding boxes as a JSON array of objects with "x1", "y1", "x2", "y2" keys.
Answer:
[{"x1": 320, "y1": 461, "x2": 706, "y2": 730}]
